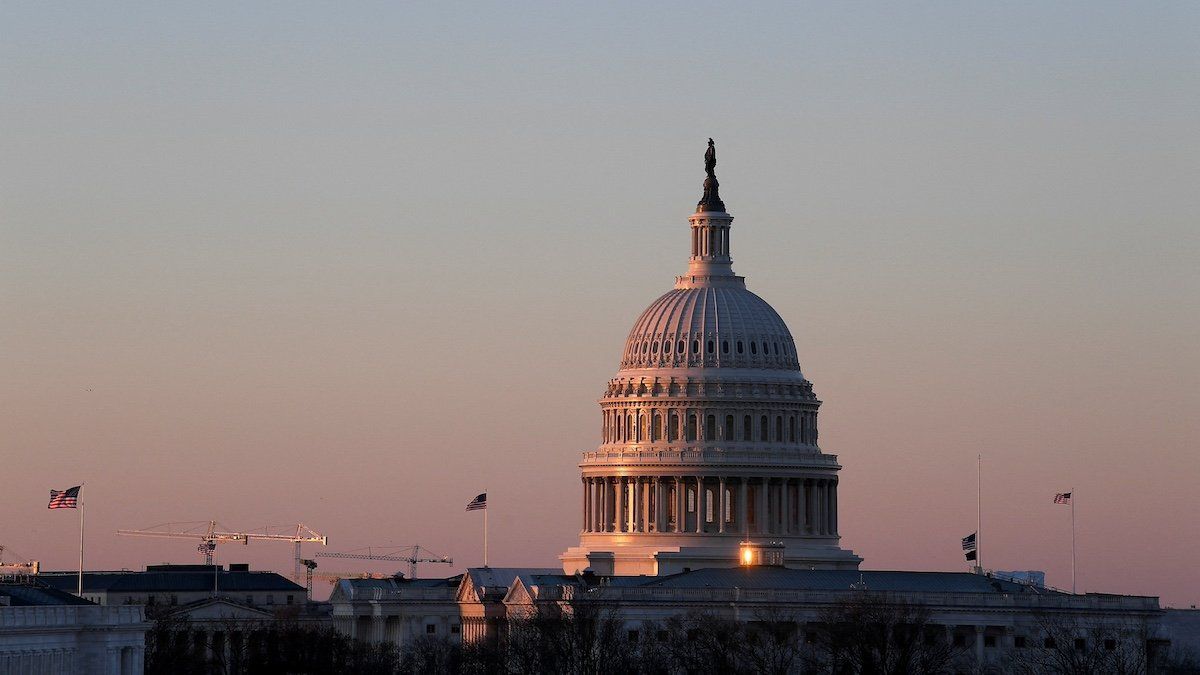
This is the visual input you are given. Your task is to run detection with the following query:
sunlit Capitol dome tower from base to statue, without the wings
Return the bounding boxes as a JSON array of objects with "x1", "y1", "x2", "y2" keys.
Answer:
[{"x1": 560, "y1": 141, "x2": 860, "y2": 574}]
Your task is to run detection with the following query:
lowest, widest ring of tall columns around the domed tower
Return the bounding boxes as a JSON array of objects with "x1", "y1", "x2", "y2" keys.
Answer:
[{"x1": 582, "y1": 474, "x2": 838, "y2": 536}]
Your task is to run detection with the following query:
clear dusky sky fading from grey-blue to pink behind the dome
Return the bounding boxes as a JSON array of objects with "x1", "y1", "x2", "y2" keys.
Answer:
[{"x1": 0, "y1": 1, "x2": 1200, "y2": 607}]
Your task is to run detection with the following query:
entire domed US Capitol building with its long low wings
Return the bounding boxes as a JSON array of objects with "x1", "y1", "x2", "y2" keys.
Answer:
[{"x1": 330, "y1": 139, "x2": 1170, "y2": 673}]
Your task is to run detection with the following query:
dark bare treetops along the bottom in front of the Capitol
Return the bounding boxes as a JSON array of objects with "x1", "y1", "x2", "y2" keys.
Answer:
[{"x1": 145, "y1": 593, "x2": 1194, "y2": 675}]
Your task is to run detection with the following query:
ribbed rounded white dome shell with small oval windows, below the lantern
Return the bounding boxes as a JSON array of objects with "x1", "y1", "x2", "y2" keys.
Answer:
[{"x1": 620, "y1": 285, "x2": 800, "y2": 371}]
